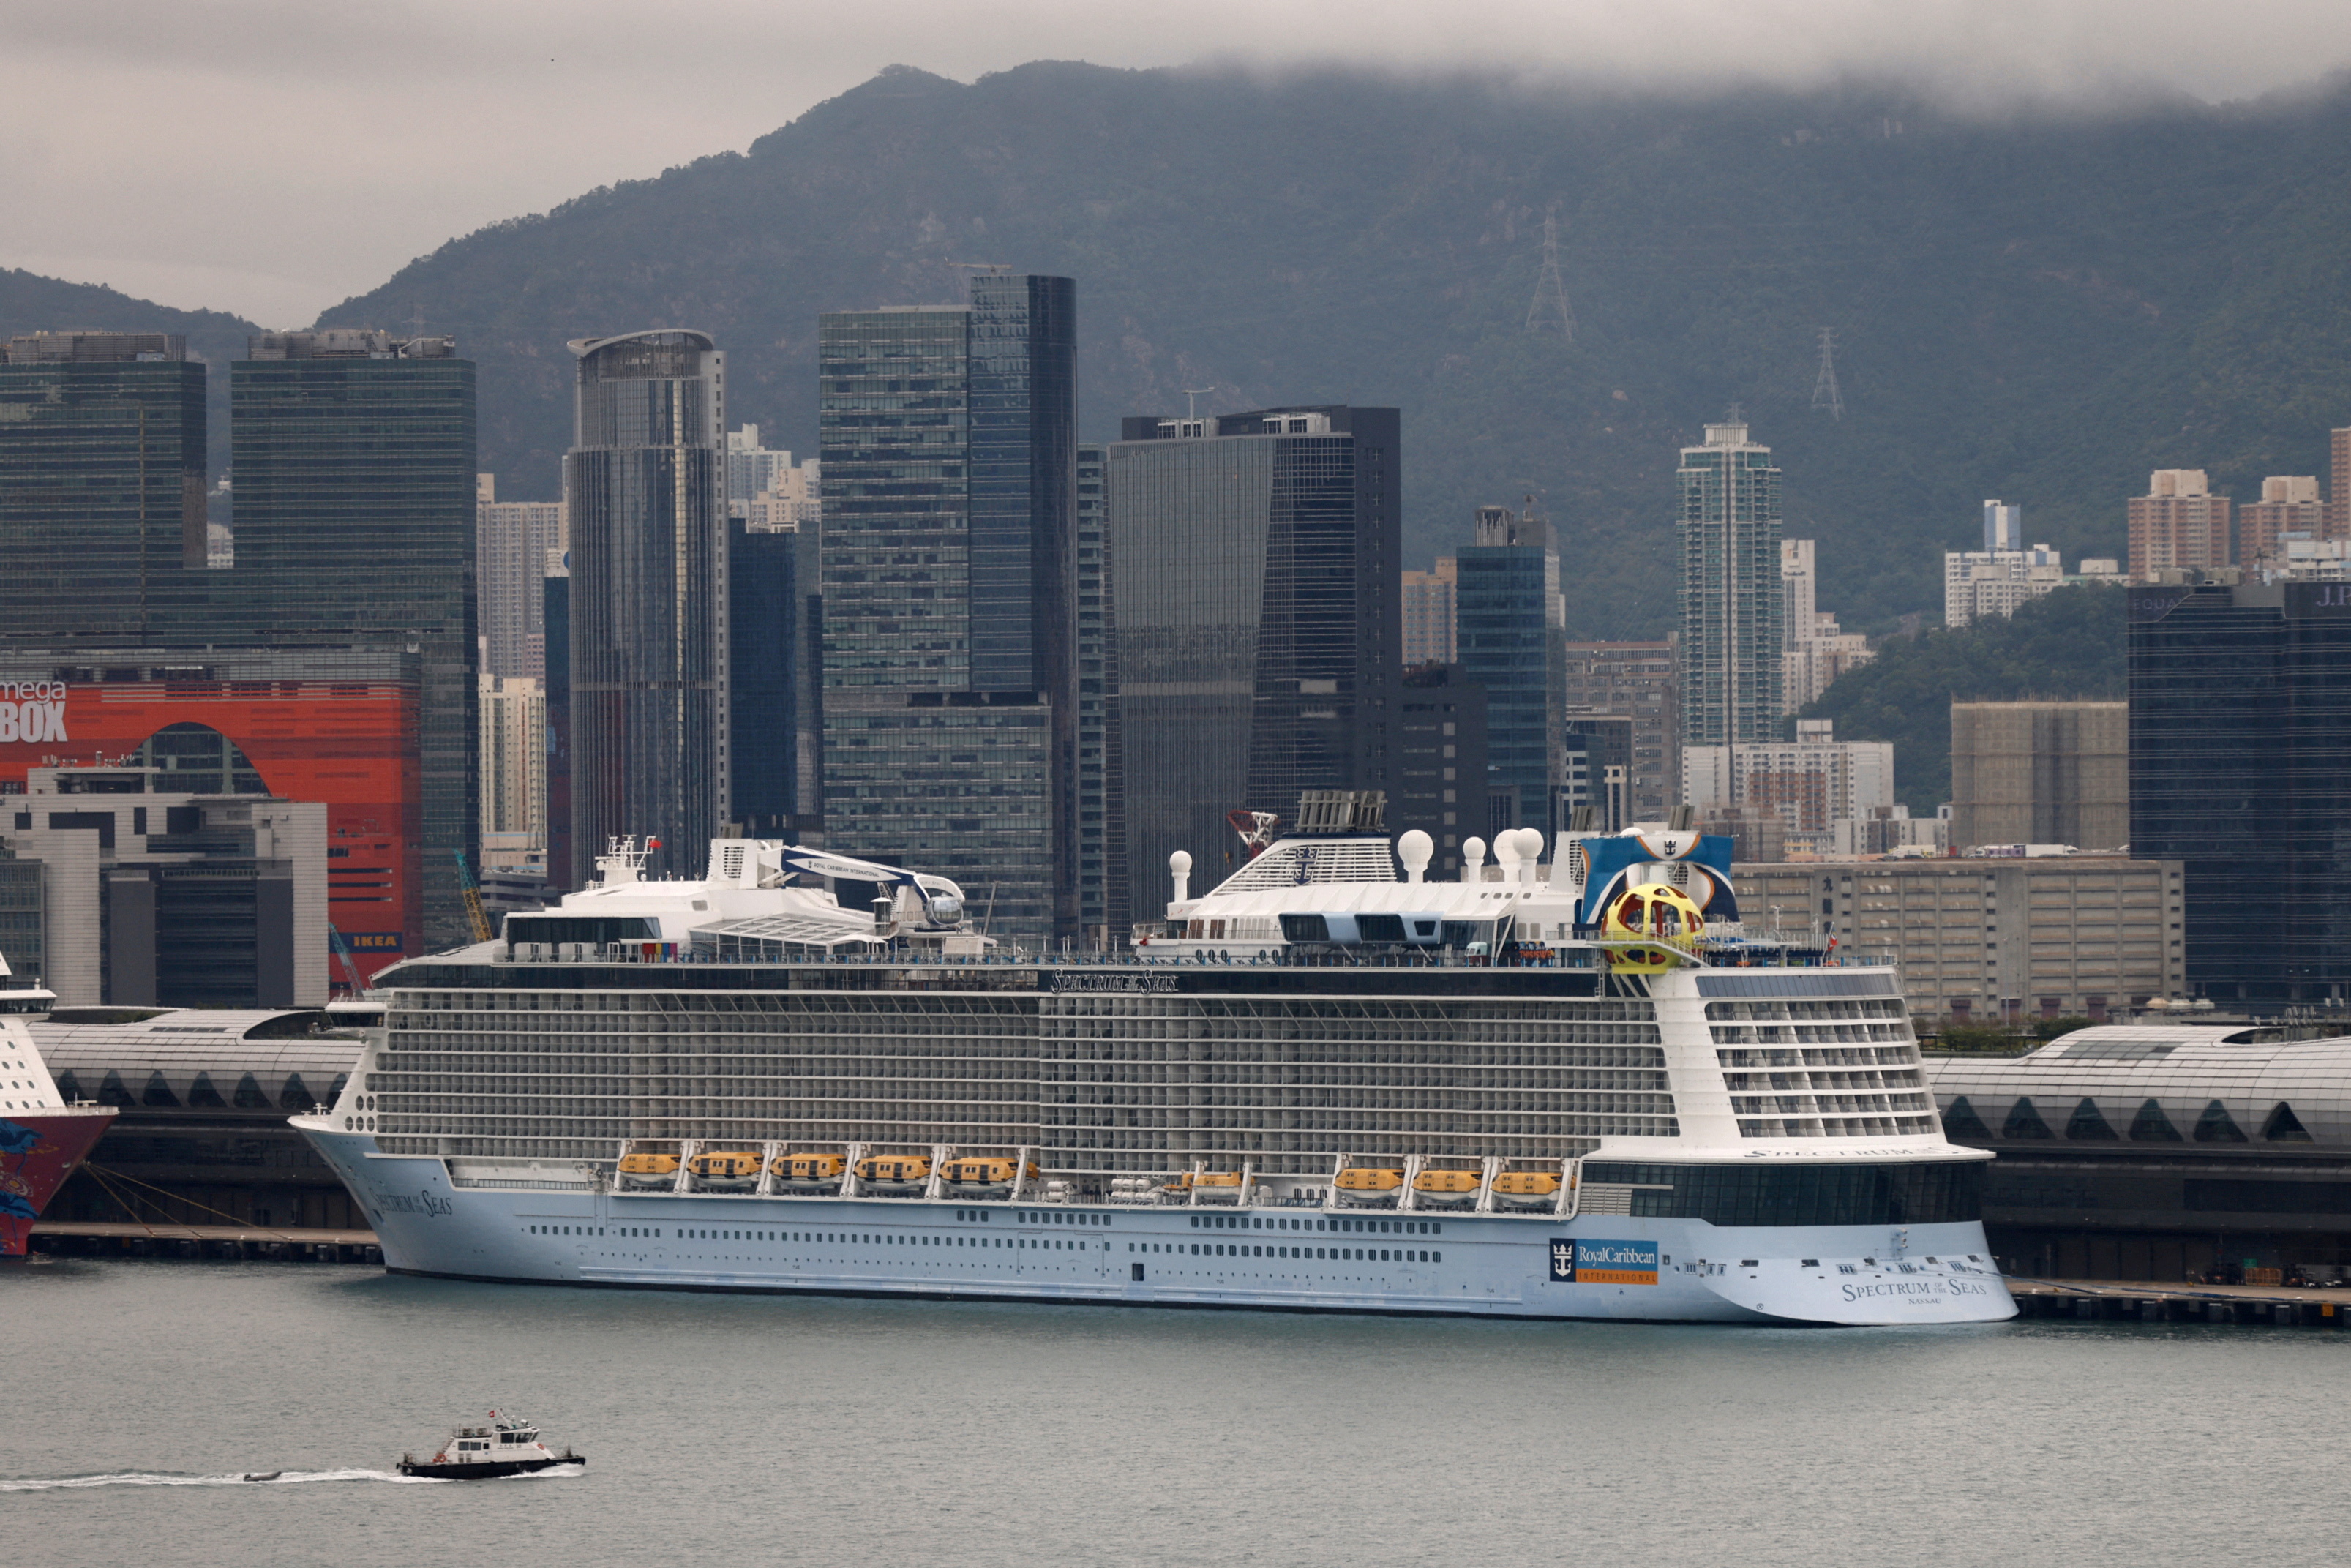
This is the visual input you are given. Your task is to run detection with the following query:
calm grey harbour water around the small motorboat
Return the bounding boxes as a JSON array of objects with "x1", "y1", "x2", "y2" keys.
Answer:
[{"x1": 0, "y1": 1260, "x2": 2351, "y2": 1568}]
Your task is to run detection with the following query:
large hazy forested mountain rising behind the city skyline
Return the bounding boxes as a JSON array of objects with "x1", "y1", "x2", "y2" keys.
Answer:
[{"x1": 0, "y1": 64, "x2": 2351, "y2": 634}]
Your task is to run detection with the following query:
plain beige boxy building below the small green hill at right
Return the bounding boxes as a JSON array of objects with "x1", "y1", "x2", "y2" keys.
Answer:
[{"x1": 1951, "y1": 703, "x2": 2130, "y2": 849}]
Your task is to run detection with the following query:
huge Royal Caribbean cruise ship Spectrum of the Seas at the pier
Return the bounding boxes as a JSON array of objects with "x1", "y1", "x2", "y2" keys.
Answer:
[{"x1": 294, "y1": 792, "x2": 2015, "y2": 1324}]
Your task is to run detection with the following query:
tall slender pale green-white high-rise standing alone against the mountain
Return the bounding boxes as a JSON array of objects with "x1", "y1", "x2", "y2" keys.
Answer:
[{"x1": 1674, "y1": 421, "x2": 1787, "y2": 752}]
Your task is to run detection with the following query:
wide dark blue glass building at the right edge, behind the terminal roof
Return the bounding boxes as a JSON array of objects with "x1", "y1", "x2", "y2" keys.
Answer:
[{"x1": 2116, "y1": 583, "x2": 2351, "y2": 1011}]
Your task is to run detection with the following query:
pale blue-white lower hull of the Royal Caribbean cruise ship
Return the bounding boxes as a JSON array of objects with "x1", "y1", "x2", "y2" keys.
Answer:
[{"x1": 294, "y1": 1117, "x2": 2017, "y2": 1326}]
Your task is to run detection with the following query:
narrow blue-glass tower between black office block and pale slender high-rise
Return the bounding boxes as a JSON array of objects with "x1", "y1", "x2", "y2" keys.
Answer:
[{"x1": 1453, "y1": 506, "x2": 1568, "y2": 839}]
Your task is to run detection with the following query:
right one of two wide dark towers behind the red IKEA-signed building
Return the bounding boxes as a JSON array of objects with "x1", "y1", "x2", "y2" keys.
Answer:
[{"x1": 236, "y1": 327, "x2": 479, "y2": 948}]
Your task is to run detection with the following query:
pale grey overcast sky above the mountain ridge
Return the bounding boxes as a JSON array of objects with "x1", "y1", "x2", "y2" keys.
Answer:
[{"x1": 0, "y1": 0, "x2": 2351, "y2": 327}]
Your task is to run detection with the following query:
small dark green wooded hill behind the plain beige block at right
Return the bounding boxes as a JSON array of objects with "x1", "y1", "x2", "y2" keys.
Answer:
[{"x1": 1803, "y1": 588, "x2": 2130, "y2": 816}]
